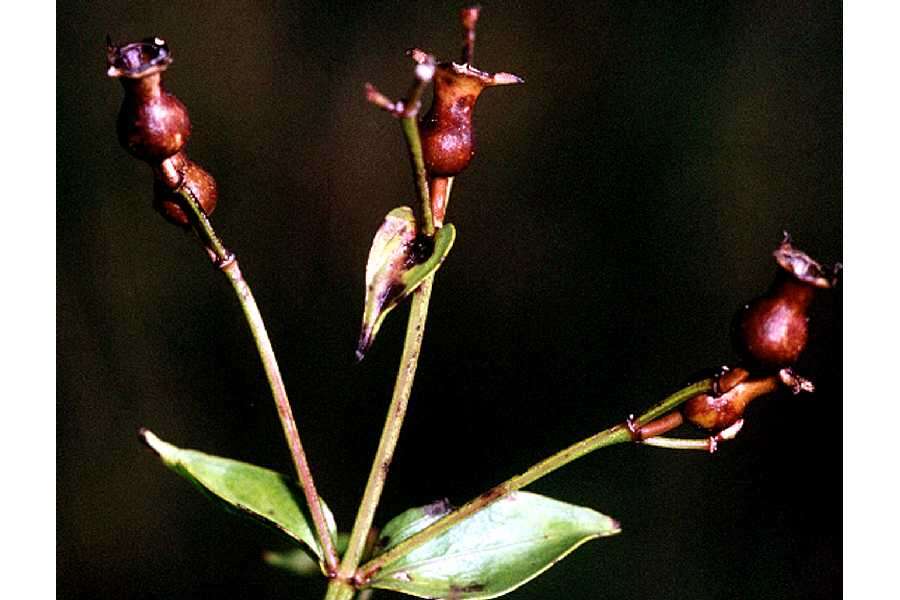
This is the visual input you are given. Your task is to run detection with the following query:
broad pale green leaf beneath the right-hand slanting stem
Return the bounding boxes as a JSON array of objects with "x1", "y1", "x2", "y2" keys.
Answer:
[{"x1": 367, "y1": 492, "x2": 621, "y2": 600}]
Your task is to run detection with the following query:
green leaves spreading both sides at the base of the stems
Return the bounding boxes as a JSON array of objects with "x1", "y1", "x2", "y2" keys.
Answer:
[{"x1": 141, "y1": 430, "x2": 620, "y2": 599}]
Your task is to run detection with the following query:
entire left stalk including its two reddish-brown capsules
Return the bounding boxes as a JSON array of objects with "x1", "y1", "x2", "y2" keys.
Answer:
[{"x1": 107, "y1": 37, "x2": 338, "y2": 573}]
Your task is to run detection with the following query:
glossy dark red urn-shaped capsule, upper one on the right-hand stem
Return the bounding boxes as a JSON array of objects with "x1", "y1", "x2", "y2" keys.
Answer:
[{"x1": 734, "y1": 235, "x2": 840, "y2": 369}]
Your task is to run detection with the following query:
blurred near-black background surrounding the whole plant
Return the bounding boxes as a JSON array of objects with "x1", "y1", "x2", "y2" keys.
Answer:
[{"x1": 57, "y1": 2, "x2": 842, "y2": 600}]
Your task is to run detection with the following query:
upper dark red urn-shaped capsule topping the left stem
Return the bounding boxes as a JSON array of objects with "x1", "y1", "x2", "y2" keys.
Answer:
[{"x1": 107, "y1": 38, "x2": 191, "y2": 163}]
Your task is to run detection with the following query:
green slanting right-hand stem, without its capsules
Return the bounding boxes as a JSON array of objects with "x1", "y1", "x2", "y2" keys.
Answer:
[{"x1": 356, "y1": 379, "x2": 713, "y2": 584}]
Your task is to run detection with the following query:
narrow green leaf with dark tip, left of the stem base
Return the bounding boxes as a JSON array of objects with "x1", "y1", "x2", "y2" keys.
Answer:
[{"x1": 141, "y1": 429, "x2": 335, "y2": 559}]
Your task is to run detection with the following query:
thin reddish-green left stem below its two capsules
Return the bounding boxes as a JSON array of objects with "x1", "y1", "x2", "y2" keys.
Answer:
[{"x1": 179, "y1": 187, "x2": 339, "y2": 573}]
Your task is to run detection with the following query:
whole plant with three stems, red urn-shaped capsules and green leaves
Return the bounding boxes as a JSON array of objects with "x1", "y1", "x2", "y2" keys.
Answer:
[{"x1": 107, "y1": 7, "x2": 836, "y2": 600}]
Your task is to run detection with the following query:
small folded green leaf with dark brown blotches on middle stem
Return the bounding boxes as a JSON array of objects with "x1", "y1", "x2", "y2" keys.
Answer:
[{"x1": 356, "y1": 206, "x2": 456, "y2": 360}]
